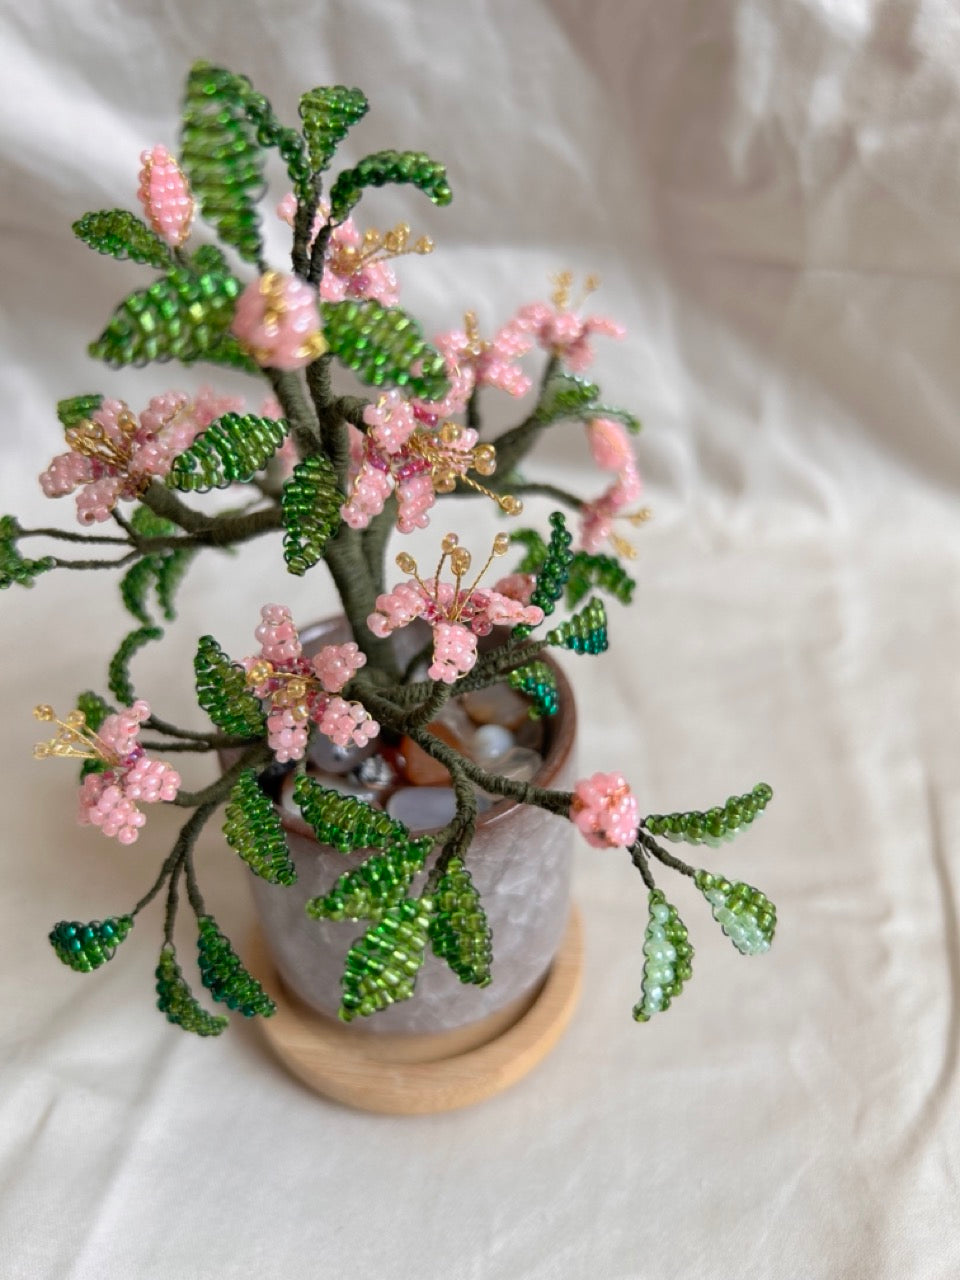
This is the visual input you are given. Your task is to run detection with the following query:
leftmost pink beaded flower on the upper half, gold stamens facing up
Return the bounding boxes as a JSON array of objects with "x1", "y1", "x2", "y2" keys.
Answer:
[{"x1": 40, "y1": 388, "x2": 243, "y2": 525}]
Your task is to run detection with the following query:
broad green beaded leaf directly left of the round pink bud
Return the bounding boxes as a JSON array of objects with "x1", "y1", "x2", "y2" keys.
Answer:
[{"x1": 88, "y1": 255, "x2": 249, "y2": 371}]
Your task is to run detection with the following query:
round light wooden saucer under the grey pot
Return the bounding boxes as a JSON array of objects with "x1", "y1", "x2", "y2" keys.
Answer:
[{"x1": 251, "y1": 908, "x2": 584, "y2": 1115}]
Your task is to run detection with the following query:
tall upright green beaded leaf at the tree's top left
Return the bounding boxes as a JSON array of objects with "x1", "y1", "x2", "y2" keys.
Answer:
[{"x1": 180, "y1": 61, "x2": 266, "y2": 262}]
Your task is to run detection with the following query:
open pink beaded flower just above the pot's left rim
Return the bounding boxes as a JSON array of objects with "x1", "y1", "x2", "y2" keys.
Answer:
[{"x1": 243, "y1": 604, "x2": 380, "y2": 764}]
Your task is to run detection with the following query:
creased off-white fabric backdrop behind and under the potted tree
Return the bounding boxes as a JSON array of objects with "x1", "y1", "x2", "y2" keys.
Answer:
[{"x1": 0, "y1": 0, "x2": 960, "y2": 1280}]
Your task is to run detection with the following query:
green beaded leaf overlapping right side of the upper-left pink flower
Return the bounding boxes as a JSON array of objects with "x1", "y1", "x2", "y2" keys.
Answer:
[{"x1": 166, "y1": 413, "x2": 287, "y2": 493}]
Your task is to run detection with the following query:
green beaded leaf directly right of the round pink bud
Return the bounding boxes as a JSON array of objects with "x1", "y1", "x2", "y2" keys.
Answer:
[{"x1": 320, "y1": 298, "x2": 447, "y2": 401}]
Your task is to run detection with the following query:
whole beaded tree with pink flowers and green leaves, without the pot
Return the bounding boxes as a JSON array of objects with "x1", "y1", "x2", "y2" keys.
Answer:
[{"x1": 0, "y1": 63, "x2": 776, "y2": 1036}]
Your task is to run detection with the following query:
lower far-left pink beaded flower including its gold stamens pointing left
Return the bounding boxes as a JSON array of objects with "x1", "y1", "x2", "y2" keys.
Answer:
[{"x1": 33, "y1": 699, "x2": 180, "y2": 845}]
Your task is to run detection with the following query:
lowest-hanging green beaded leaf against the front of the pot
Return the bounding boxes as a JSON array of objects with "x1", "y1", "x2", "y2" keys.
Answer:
[{"x1": 338, "y1": 897, "x2": 433, "y2": 1023}]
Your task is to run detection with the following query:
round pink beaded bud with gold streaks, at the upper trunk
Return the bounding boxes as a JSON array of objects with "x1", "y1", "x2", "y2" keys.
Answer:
[{"x1": 230, "y1": 271, "x2": 326, "y2": 370}]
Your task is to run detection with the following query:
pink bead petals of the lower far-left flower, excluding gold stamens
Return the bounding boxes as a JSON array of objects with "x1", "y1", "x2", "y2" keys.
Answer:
[{"x1": 78, "y1": 699, "x2": 180, "y2": 845}]
